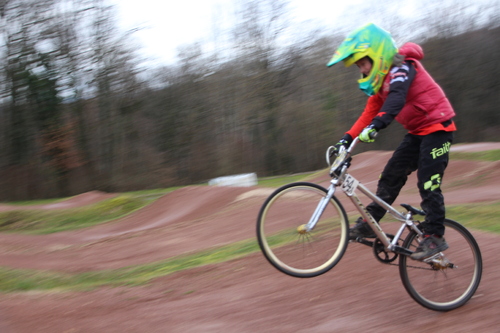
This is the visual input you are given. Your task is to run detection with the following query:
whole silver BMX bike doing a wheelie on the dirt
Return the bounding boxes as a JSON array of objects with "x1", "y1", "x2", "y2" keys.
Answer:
[{"x1": 257, "y1": 138, "x2": 482, "y2": 311}]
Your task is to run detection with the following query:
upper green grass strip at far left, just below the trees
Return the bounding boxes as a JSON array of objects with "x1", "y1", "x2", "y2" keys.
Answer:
[{"x1": 0, "y1": 195, "x2": 152, "y2": 234}]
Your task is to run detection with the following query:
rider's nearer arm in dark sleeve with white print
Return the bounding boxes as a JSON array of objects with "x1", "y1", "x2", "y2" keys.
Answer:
[{"x1": 371, "y1": 61, "x2": 416, "y2": 130}]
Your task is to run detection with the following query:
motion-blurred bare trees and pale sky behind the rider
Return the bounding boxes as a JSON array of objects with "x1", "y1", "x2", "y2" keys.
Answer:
[{"x1": 0, "y1": 0, "x2": 500, "y2": 201}]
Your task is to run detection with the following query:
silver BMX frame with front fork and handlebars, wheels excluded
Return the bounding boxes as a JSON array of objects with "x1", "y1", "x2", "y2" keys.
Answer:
[{"x1": 306, "y1": 138, "x2": 422, "y2": 255}]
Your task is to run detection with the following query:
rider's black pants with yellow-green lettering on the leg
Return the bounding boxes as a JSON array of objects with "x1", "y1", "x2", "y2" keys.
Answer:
[{"x1": 367, "y1": 131, "x2": 453, "y2": 236}]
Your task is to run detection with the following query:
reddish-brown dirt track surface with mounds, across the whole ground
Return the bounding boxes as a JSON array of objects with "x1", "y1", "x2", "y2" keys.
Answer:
[{"x1": 0, "y1": 143, "x2": 500, "y2": 333}]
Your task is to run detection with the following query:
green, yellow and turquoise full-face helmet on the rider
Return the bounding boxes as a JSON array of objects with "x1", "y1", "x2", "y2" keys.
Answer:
[{"x1": 327, "y1": 23, "x2": 398, "y2": 96}]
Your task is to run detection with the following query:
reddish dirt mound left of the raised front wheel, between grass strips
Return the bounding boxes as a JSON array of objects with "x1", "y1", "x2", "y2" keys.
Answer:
[{"x1": 0, "y1": 186, "x2": 254, "y2": 272}]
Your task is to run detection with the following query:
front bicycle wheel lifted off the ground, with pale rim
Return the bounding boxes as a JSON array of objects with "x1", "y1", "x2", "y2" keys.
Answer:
[{"x1": 257, "y1": 182, "x2": 349, "y2": 278}]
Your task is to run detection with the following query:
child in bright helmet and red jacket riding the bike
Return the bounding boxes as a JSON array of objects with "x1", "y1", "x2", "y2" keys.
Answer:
[{"x1": 327, "y1": 23, "x2": 456, "y2": 260}]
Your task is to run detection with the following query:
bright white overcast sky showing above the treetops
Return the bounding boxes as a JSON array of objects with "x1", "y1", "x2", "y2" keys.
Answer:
[{"x1": 110, "y1": 0, "x2": 498, "y2": 65}]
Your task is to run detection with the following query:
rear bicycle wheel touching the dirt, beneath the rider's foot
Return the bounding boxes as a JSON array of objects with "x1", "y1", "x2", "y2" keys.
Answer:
[{"x1": 399, "y1": 219, "x2": 483, "y2": 311}]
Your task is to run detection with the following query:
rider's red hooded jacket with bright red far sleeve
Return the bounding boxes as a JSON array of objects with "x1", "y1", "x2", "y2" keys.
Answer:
[{"x1": 347, "y1": 43, "x2": 455, "y2": 137}]
